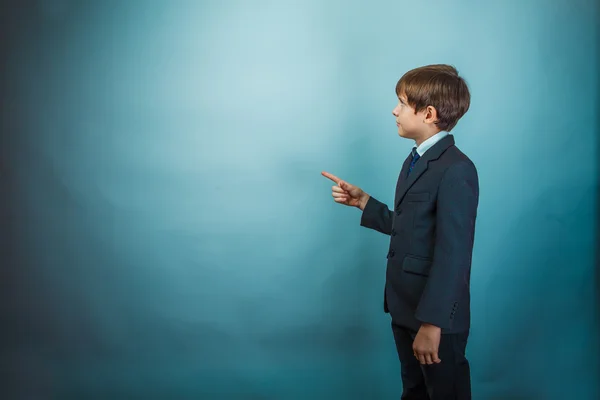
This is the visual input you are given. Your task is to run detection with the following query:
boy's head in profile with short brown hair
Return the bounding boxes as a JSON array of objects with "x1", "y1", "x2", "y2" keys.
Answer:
[{"x1": 392, "y1": 64, "x2": 471, "y2": 144}]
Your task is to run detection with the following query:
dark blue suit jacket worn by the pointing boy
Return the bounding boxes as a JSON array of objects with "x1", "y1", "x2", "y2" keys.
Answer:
[{"x1": 361, "y1": 135, "x2": 479, "y2": 333}]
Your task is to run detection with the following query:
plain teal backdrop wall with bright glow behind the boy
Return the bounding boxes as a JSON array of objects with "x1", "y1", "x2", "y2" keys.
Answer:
[{"x1": 0, "y1": 0, "x2": 600, "y2": 400}]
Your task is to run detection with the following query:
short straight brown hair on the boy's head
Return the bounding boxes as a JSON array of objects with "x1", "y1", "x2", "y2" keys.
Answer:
[{"x1": 396, "y1": 64, "x2": 471, "y2": 132}]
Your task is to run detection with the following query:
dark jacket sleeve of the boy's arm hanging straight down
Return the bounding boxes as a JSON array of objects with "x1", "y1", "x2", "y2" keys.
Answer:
[{"x1": 415, "y1": 162, "x2": 479, "y2": 329}]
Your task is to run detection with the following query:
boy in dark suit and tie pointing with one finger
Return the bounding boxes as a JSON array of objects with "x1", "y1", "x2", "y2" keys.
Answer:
[{"x1": 322, "y1": 65, "x2": 479, "y2": 400}]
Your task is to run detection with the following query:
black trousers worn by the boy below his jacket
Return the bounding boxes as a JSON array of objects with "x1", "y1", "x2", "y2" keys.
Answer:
[{"x1": 392, "y1": 322, "x2": 471, "y2": 400}]
